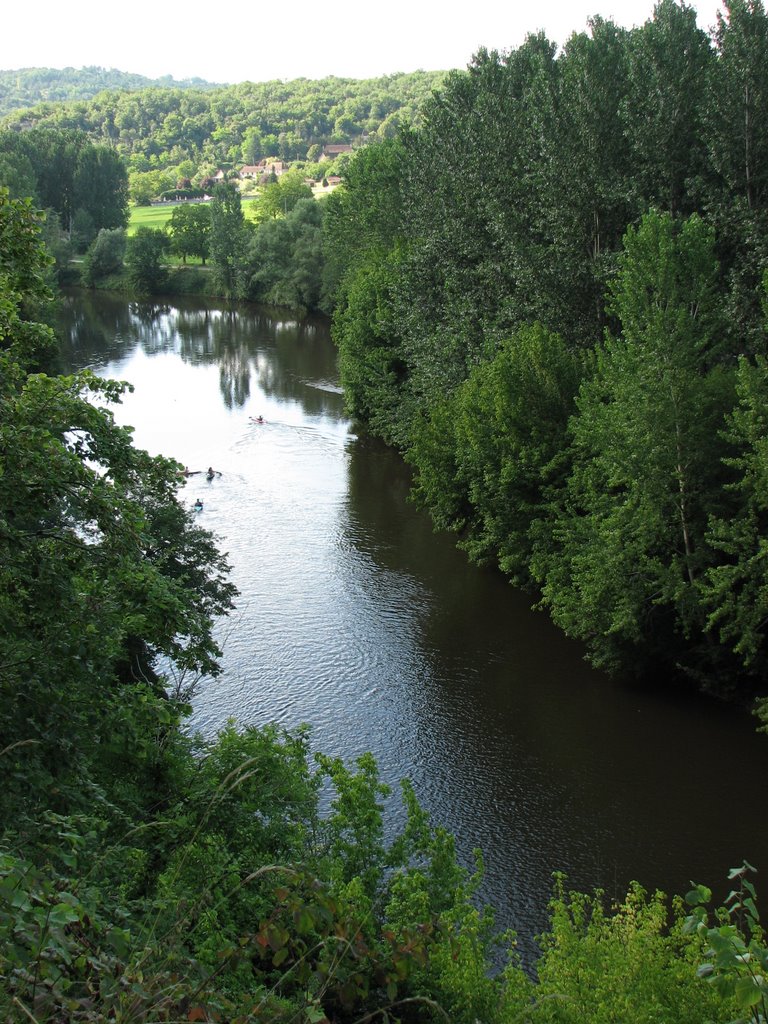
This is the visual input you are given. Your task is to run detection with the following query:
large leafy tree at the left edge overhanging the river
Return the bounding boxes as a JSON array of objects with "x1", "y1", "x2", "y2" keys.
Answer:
[{"x1": 0, "y1": 194, "x2": 234, "y2": 810}]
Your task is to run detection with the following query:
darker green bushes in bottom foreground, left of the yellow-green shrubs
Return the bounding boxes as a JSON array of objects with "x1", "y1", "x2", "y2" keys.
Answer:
[{"x1": 0, "y1": 727, "x2": 524, "y2": 1024}]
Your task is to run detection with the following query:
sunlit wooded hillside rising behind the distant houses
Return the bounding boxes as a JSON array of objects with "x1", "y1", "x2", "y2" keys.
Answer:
[{"x1": 0, "y1": 72, "x2": 444, "y2": 201}]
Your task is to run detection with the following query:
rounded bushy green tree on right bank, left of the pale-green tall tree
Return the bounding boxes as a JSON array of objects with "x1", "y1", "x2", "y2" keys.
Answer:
[{"x1": 408, "y1": 326, "x2": 586, "y2": 584}]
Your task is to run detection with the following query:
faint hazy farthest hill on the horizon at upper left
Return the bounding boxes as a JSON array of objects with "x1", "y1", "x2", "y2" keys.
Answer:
[{"x1": 0, "y1": 67, "x2": 217, "y2": 117}]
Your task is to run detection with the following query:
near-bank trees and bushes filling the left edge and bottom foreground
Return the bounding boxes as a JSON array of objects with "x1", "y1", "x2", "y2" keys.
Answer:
[{"x1": 6, "y1": 189, "x2": 768, "y2": 1024}]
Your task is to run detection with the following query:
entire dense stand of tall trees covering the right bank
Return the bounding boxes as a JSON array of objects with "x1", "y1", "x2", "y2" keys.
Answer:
[{"x1": 326, "y1": 0, "x2": 768, "y2": 696}]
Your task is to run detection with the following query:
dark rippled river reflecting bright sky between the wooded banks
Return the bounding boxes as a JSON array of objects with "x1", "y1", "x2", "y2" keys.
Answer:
[{"x1": 62, "y1": 294, "x2": 768, "y2": 956}]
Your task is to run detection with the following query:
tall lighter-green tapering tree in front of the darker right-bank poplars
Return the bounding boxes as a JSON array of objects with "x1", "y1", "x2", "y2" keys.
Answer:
[{"x1": 536, "y1": 212, "x2": 730, "y2": 669}]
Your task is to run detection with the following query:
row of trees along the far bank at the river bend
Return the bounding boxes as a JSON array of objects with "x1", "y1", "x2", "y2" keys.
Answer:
[{"x1": 0, "y1": 119, "x2": 325, "y2": 303}]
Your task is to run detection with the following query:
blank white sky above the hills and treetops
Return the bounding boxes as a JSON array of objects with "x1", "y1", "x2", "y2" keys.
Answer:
[{"x1": 0, "y1": 0, "x2": 722, "y2": 83}]
